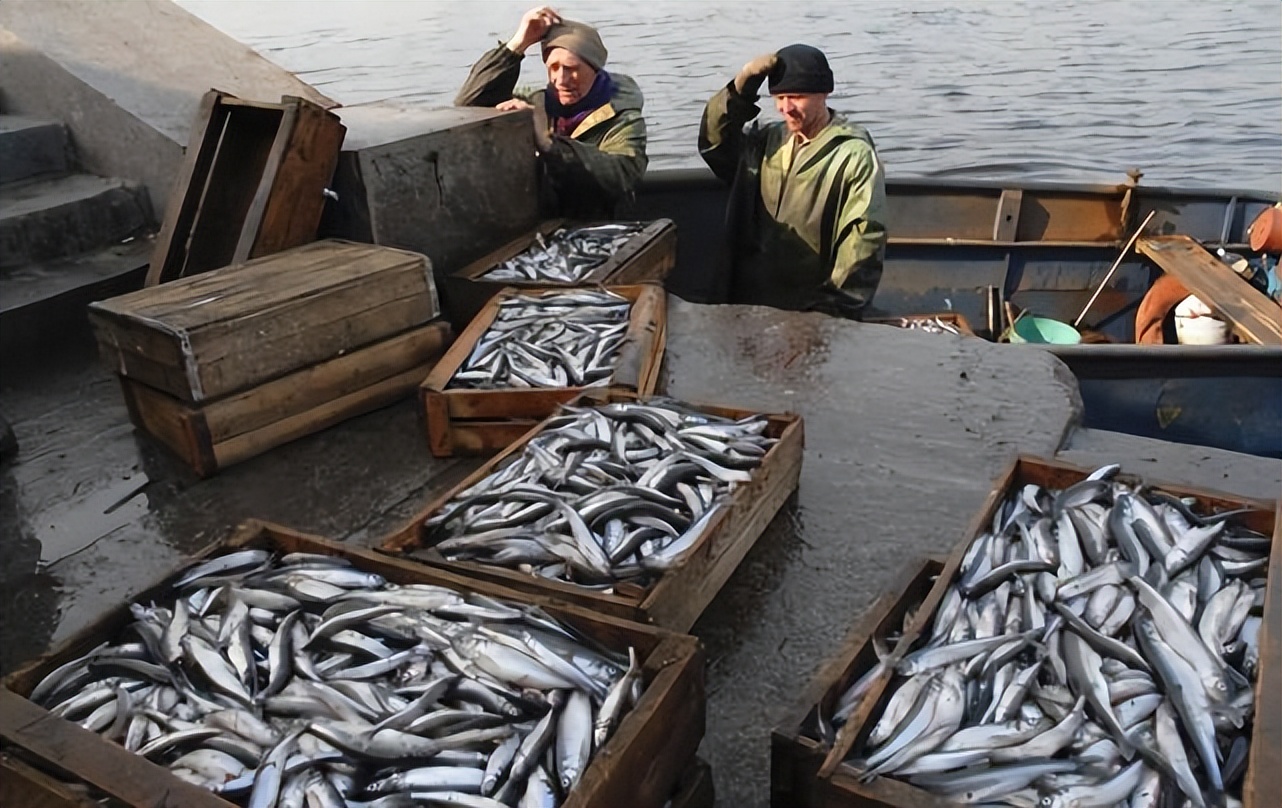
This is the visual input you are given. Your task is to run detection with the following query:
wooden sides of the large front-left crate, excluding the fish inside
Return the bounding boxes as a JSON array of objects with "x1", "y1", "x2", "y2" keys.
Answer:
[{"x1": 0, "y1": 521, "x2": 705, "y2": 808}]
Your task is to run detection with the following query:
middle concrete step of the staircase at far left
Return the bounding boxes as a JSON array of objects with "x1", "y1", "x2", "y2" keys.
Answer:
[{"x1": 0, "y1": 174, "x2": 154, "y2": 269}]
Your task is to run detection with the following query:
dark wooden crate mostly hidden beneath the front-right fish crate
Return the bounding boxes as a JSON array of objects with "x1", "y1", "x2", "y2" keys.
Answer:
[{"x1": 770, "y1": 558, "x2": 944, "y2": 808}]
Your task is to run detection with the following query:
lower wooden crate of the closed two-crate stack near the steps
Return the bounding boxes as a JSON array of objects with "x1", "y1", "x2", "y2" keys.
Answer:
[{"x1": 119, "y1": 321, "x2": 453, "y2": 477}]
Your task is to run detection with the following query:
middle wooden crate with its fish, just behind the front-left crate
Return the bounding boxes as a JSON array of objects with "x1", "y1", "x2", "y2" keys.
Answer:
[{"x1": 379, "y1": 391, "x2": 804, "y2": 631}]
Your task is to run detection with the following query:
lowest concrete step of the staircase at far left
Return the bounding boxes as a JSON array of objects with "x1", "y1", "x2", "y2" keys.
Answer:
[{"x1": 0, "y1": 236, "x2": 155, "y2": 368}]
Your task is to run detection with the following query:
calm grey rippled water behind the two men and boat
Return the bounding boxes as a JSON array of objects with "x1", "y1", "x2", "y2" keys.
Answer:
[{"x1": 179, "y1": 0, "x2": 1282, "y2": 191}]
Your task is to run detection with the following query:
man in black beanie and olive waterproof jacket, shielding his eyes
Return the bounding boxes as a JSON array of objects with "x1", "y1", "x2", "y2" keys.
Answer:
[{"x1": 699, "y1": 45, "x2": 886, "y2": 319}]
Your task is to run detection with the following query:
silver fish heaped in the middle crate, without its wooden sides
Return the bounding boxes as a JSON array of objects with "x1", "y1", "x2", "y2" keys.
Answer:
[{"x1": 423, "y1": 399, "x2": 774, "y2": 591}]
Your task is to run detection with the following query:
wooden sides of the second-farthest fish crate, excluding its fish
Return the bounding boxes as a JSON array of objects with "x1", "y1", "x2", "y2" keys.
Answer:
[{"x1": 419, "y1": 285, "x2": 668, "y2": 458}]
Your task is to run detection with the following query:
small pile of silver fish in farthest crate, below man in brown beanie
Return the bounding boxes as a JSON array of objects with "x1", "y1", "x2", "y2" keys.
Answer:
[{"x1": 481, "y1": 222, "x2": 646, "y2": 283}]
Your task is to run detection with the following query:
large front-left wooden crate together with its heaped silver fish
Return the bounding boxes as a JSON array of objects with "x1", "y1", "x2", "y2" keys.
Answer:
[{"x1": 0, "y1": 522, "x2": 704, "y2": 808}]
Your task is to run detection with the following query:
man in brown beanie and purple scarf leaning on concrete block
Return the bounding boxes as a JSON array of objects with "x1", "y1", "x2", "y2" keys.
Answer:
[{"x1": 454, "y1": 6, "x2": 647, "y2": 218}]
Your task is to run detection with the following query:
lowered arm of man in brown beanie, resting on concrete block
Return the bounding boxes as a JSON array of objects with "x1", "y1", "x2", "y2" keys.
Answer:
[{"x1": 544, "y1": 110, "x2": 649, "y2": 199}]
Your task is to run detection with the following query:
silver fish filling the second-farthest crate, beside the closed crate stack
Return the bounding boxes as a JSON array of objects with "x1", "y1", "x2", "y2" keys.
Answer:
[{"x1": 449, "y1": 289, "x2": 632, "y2": 390}]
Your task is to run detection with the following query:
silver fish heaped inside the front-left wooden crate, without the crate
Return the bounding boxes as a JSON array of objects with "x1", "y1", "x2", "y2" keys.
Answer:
[{"x1": 31, "y1": 550, "x2": 642, "y2": 808}]
